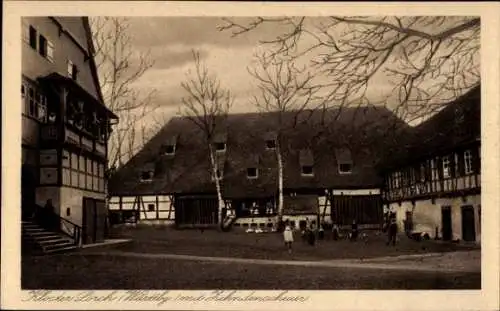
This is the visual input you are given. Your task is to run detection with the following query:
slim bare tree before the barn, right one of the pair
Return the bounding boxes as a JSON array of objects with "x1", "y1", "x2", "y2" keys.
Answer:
[{"x1": 248, "y1": 52, "x2": 318, "y2": 224}]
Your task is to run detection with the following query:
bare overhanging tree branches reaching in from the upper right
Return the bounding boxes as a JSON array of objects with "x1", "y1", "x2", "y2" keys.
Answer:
[{"x1": 219, "y1": 16, "x2": 480, "y2": 122}]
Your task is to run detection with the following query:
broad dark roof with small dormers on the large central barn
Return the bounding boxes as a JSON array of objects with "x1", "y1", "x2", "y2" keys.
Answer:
[{"x1": 109, "y1": 106, "x2": 409, "y2": 198}]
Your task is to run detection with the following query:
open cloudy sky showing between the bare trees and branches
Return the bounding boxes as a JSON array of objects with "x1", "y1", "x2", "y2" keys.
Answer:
[{"x1": 95, "y1": 16, "x2": 478, "y2": 162}]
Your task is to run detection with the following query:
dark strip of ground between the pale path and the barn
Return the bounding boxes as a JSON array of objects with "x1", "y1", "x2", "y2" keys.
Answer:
[{"x1": 103, "y1": 227, "x2": 478, "y2": 260}]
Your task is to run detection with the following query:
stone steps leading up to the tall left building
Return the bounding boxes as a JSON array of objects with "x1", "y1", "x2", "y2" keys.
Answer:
[{"x1": 21, "y1": 220, "x2": 78, "y2": 255}]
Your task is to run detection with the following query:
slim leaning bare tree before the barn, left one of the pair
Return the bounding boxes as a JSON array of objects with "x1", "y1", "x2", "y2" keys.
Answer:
[{"x1": 181, "y1": 51, "x2": 233, "y2": 226}]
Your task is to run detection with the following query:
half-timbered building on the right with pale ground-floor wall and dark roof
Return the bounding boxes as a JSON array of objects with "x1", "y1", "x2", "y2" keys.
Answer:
[{"x1": 383, "y1": 87, "x2": 481, "y2": 242}]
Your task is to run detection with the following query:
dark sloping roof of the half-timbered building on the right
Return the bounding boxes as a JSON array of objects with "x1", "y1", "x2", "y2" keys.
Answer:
[{"x1": 384, "y1": 86, "x2": 481, "y2": 170}]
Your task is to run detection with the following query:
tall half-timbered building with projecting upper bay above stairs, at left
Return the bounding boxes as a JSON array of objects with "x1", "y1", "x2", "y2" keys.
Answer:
[{"x1": 20, "y1": 17, "x2": 117, "y2": 244}]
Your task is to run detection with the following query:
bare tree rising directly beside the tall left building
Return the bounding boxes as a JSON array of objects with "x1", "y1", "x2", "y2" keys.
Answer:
[{"x1": 91, "y1": 17, "x2": 162, "y2": 167}]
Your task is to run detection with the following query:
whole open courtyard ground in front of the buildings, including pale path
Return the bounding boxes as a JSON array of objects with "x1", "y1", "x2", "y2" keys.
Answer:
[{"x1": 22, "y1": 228, "x2": 481, "y2": 289}]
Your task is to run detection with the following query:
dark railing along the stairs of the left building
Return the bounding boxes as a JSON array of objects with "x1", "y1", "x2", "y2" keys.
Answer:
[{"x1": 27, "y1": 204, "x2": 82, "y2": 246}]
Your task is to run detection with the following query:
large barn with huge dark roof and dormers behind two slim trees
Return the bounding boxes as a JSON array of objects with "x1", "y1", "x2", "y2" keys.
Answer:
[{"x1": 109, "y1": 106, "x2": 409, "y2": 232}]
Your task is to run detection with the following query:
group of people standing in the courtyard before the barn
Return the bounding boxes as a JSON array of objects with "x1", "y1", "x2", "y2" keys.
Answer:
[{"x1": 283, "y1": 217, "x2": 398, "y2": 253}]
